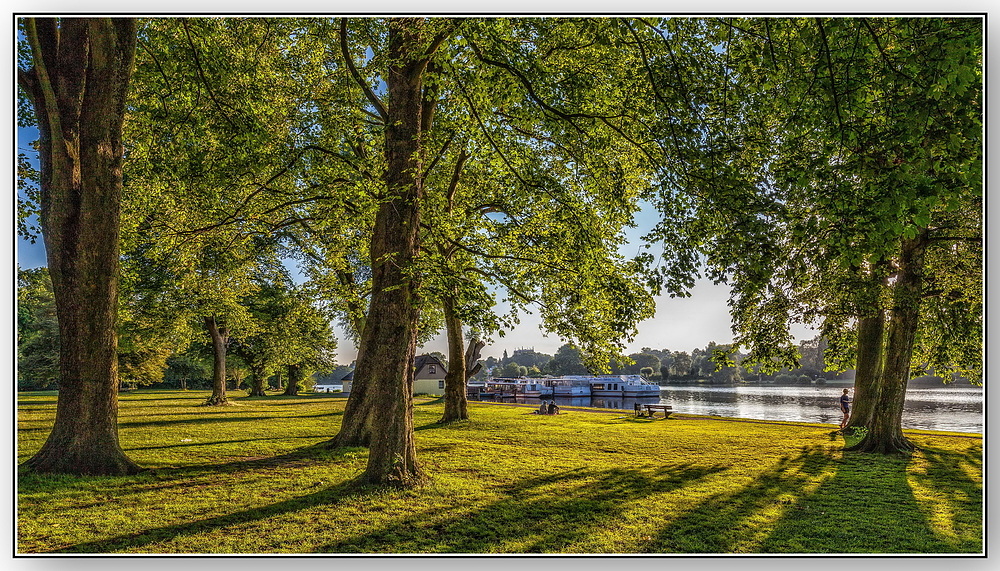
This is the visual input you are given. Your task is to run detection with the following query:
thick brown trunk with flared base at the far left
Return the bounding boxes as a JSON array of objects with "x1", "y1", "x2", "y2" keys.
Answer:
[{"x1": 19, "y1": 18, "x2": 140, "y2": 475}]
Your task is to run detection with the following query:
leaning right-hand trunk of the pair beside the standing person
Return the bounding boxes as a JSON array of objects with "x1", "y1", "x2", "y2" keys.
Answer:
[{"x1": 848, "y1": 235, "x2": 927, "y2": 454}]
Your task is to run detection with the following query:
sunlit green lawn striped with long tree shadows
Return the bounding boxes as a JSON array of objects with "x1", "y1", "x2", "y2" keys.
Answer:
[{"x1": 17, "y1": 390, "x2": 983, "y2": 554}]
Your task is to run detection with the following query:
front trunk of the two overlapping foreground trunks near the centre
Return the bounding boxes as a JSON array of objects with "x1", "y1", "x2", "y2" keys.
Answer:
[{"x1": 334, "y1": 19, "x2": 426, "y2": 486}]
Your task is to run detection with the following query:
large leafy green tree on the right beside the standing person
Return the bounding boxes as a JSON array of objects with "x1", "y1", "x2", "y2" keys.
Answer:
[{"x1": 660, "y1": 18, "x2": 982, "y2": 452}]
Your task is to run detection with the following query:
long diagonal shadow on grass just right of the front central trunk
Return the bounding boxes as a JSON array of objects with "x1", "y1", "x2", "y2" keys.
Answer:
[{"x1": 317, "y1": 465, "x2": 726, "y2": 553}]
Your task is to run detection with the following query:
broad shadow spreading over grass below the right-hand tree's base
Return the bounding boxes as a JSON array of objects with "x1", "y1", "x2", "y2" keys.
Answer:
[{"x1": 648, "y1": 447, "x2": 982, "y2": 554}]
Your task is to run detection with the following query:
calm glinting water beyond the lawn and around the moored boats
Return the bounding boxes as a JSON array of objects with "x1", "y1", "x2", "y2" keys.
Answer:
[{"x1": 480, "y1": 385, "x2": 983, "y2": 433}]
